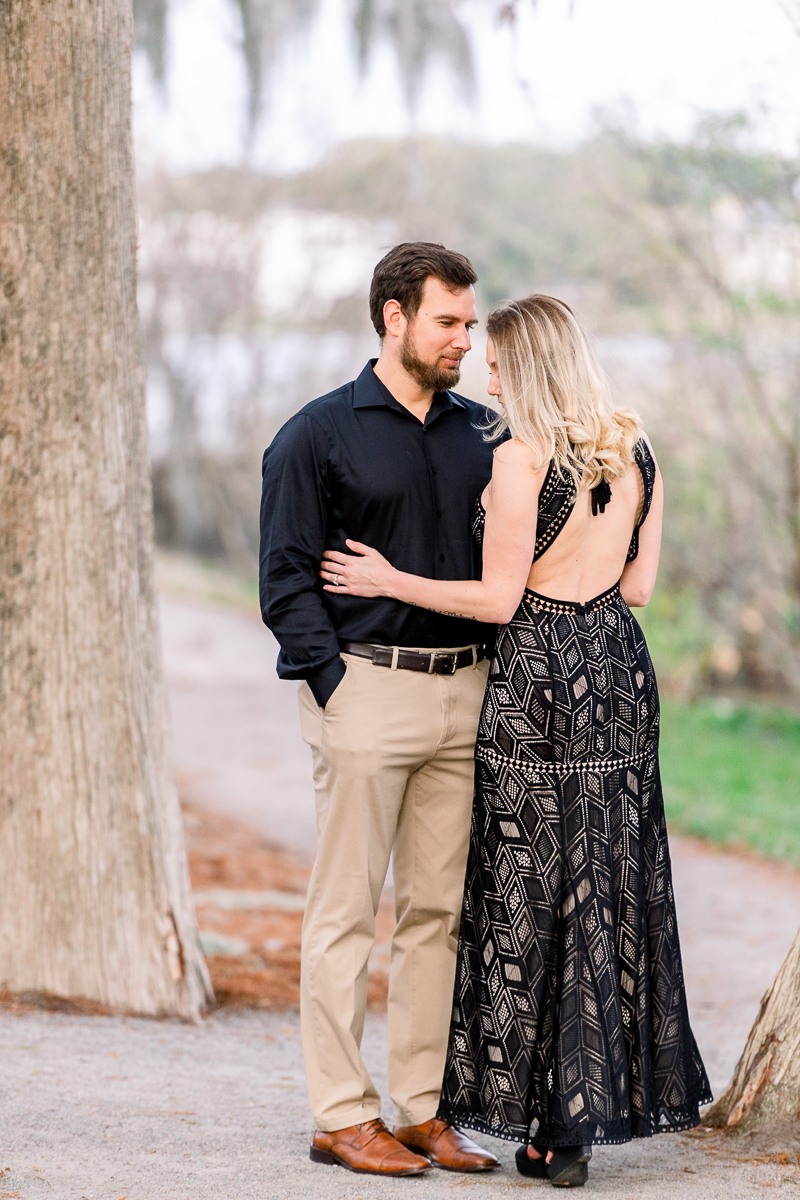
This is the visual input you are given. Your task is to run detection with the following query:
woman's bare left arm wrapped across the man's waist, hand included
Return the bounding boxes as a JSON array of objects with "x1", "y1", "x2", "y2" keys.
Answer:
[{"x1": 320, "y1": 440, "x2": 545, "y2": 625}]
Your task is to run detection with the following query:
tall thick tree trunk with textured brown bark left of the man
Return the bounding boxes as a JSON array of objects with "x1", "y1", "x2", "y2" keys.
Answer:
[{"x1": 0, "y1": 0, "x2": 210, "y2": 1018}]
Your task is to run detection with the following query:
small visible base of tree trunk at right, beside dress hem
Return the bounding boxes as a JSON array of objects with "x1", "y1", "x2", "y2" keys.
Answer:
[{"x1": 703, "y1": 934, "x2": 800, "y2": 1133}]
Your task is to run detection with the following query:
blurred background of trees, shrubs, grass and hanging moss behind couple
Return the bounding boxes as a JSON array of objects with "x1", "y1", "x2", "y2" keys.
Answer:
[{"x1": 134, "y1": 0, "x2": 800, "y2": 860}]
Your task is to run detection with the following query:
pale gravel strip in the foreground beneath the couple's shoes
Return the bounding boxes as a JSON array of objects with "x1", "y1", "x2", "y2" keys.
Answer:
[{"x1": 0, "y1": 1013, "x2": 795, "y2": 1200}]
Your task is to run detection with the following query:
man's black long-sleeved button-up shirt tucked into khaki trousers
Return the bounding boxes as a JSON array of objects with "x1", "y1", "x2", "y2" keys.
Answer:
[{"x1": 260, "y1": 362, "x2": 494, "y2": 704}]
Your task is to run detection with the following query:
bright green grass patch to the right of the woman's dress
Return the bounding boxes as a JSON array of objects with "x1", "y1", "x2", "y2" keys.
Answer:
[{"x1": 661, "y1": 698, "x2": 800, "y2": 863}]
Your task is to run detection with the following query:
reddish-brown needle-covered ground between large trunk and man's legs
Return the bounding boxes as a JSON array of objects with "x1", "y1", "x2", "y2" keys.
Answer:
[{"x1": 184, "y1": 805, "x2": 393, "y2": 1010}]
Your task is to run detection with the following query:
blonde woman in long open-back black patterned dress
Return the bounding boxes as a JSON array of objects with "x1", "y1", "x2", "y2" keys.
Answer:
[{"x1": 321, "y1": 295, "x2": 711, "y2": 1186}]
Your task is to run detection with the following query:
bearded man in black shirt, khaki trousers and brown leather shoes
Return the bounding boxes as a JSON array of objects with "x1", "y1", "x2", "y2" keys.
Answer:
[{"x1": 260, "y1": 242, "x2": 499, "y2": 1175}]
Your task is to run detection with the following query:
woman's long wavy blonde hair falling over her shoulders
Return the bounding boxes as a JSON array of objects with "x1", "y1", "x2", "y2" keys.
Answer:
[{"x1": 487, "y1": 295, "x2": 642, "y2": 491}]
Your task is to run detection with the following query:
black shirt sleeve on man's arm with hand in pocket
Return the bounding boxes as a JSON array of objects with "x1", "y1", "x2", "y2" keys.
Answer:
[{"x1": 259, "y1": 413, "x2": 345, "y2": 707}]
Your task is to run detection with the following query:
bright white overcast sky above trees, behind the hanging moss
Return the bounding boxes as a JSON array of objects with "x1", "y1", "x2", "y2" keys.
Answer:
[{"x1": 134, "y1": 0, "x2": 800, "y2": 170}]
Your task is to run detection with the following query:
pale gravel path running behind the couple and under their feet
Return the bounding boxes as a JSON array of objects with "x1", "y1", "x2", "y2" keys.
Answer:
[{"x1": 0, "y1": 600, "x2": 800, "y2": 1200}]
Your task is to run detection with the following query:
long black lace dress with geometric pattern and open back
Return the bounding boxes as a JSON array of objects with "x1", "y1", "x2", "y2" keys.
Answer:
[{"x1": 439, "y1": 442, "x2": 711, "y2": 1146}]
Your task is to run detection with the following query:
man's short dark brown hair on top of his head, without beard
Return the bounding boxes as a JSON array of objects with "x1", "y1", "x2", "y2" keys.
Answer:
[{"x1": 369, "y1": 241, "x2": 477, "y2": 337}]
